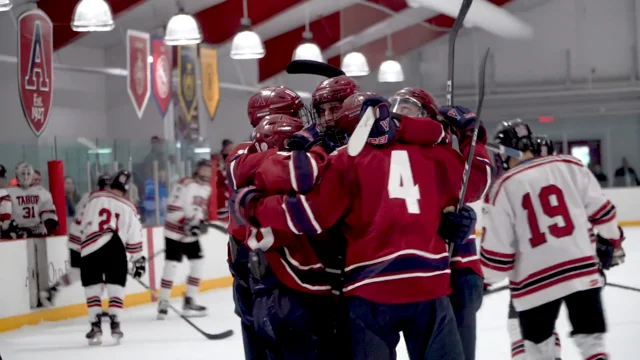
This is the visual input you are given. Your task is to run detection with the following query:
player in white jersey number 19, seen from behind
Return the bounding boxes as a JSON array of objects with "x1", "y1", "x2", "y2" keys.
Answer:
[{"x1": 481, "y1": 121, "x2": 624, "y2": 360}]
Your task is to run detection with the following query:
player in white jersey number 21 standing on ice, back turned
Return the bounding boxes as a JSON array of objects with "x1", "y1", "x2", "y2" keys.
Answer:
[{"x1": 80, "y1": 170, "x2": 146, "y2": 345}]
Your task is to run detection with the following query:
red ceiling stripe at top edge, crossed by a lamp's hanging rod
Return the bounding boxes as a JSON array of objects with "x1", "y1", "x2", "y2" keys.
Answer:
[{"x1": 195, "y1": 0, "x2": 303, "y2": 44}]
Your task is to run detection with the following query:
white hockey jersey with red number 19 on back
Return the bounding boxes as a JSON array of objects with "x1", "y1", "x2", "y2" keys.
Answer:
[{"x1": 480, "y1": 155, "x2": 621, "y2": 311}]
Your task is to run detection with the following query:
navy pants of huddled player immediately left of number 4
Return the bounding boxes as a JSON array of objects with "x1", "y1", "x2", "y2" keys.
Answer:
[{"x1": 251, "y1": 250, "x2": 337, "y2": 360}]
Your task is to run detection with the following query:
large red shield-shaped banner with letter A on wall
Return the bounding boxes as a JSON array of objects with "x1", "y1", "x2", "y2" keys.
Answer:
[{"x1": 18, "y1": 9, "x2": 53, "y2": 136}]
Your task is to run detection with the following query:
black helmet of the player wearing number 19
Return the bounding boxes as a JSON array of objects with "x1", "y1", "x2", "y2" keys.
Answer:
[{"x1": 494, "y1": 119, "x2": 535, "y2": 170}]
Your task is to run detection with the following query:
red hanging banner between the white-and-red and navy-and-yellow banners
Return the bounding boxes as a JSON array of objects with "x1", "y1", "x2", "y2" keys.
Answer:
[{"x1": 151, "y1": 36, "x2": 172, "y2": 118}]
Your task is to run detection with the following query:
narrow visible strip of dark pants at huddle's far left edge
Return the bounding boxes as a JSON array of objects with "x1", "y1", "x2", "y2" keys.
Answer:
[{"x1": 229, "y1": 236, "x2": 268, "y2": 360}]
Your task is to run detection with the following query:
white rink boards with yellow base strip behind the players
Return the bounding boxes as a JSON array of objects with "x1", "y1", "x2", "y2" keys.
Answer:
[{"x1": 0, "y1": 188, "x2": 640, "y2": 332}]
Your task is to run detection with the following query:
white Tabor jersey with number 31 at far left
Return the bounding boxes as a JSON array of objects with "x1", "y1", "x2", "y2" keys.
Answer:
[{"x1": 7, "y1": 185, "x2": 58, "y2": 234}]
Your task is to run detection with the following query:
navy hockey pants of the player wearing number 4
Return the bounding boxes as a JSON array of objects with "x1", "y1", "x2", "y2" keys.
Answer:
[{"x1": 346, "y1": 296, "x2": 464, "y2": 360}]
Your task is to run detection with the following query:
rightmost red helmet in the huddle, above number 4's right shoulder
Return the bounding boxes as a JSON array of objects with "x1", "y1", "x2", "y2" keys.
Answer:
[{"x1": 389, "y1": 88, "x2": 440, "y2": 120}]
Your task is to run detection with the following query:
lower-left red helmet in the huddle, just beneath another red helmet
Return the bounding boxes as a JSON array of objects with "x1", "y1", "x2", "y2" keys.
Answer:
[{"x1": 253, "y1": 115, "x2": 304, "y2": 151}]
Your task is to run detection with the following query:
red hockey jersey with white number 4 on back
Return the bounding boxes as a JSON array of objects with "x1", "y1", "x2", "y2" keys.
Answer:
[{"x1": 250, "y1": 135, "x2": 491, "y2": 303}]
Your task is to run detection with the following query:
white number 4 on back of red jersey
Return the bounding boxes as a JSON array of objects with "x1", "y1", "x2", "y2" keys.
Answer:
[{"x1": 387, "y1": 150, "x2": 420, "y2": 214}]
